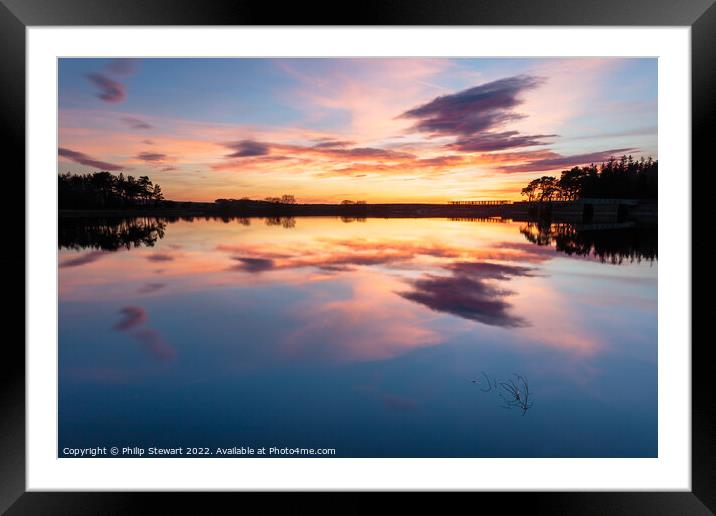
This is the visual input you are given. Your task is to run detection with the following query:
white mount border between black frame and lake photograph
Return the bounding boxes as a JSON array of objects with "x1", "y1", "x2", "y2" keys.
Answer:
[{"x1": 26, "y1": 27, "x2": 691, "y2": 491}]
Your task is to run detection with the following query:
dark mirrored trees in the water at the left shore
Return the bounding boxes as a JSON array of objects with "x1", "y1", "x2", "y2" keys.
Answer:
[{"x1": 58, "y1": 217, "x2": 166, "y2": 251}]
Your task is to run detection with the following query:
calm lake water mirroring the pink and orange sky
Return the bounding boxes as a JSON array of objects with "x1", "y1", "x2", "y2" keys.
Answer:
[{"x1": 58, "y1": 217, "x2": 657, "y2": 457}]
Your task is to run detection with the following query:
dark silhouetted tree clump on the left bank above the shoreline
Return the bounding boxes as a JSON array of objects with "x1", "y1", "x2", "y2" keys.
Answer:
[{"x1": 58, "y1": 172, "x2": 164, "y2": 209}]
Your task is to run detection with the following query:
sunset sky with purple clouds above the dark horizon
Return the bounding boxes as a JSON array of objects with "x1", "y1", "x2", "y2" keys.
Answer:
[{"x1": 58, "y1": 58, "x2": 658, "y2": 202}]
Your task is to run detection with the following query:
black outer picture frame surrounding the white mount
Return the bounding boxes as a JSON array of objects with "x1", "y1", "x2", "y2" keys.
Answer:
[{"x1": 0, "y1": 0, "x2": 716, "y2": 515}]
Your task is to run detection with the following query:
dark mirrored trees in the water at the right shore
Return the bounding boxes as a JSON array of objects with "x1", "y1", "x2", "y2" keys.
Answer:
[{"x1": 520, "y1": 221, "x2": 658, "y2": 264}]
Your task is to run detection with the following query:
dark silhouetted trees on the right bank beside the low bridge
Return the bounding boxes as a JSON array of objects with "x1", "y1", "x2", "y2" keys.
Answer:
[{"x1": 521, "y1": 156, "x2": 659, "y2": 202}]
